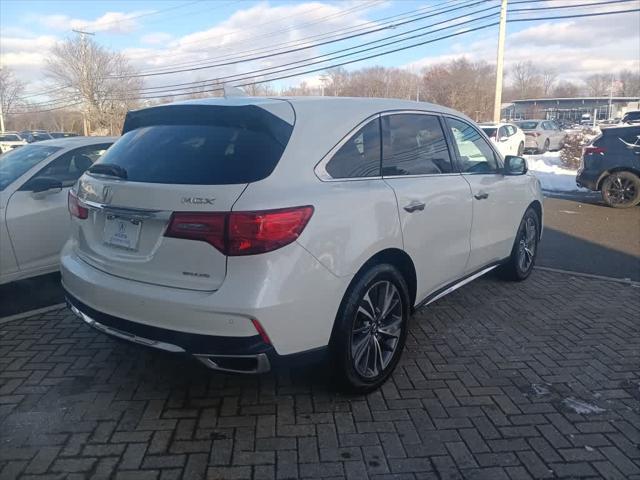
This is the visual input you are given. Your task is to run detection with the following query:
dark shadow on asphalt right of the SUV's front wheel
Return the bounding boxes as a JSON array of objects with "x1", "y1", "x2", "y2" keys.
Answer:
[{"x1": 536, "y1": 227, "x2": 640, "y2": 281}]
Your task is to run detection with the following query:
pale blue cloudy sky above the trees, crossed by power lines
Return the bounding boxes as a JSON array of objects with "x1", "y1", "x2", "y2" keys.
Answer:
[{"x1": 0, "y1": 0, "x2": 640, "y2": 97}]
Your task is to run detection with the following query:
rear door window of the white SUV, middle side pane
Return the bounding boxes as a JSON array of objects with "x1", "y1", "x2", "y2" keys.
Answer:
[{"x1": 382, "y1": 114, "x2": 453, "y2": 176}]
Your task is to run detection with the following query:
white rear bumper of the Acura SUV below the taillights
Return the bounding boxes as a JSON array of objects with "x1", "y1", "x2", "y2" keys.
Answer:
[{"x1": 60, "y1": 241, "x2": 350, "y2": 356}]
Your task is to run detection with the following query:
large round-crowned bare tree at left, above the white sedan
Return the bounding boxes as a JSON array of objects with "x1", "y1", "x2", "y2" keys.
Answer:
[{"x1": 46, "y1": 37, "x2": 143, "y2": 133}]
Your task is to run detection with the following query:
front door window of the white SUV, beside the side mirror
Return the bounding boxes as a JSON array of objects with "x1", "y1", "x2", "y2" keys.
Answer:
[{"x1": 447, "y1": 118, "x2": 499, "y2": 173}]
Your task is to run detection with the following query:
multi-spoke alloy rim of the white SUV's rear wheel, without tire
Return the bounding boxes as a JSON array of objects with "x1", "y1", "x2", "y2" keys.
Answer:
[{"x1": 351, "y1": 280, "x2": 403, "y2": 378}]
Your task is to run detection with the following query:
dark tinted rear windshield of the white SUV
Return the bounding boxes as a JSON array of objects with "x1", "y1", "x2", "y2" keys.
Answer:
[{"x1": 96, "y1": 105, "x2": 293, "y2": 185}]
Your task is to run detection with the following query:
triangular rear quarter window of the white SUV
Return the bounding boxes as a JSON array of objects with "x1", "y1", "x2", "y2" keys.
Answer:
[{"x1": 325, "y1": 118, "x2": 380, "y2": 178}]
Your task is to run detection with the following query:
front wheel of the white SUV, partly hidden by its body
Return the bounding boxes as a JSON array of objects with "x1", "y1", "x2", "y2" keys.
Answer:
[{"x1": 498, "y1": 207, "x2": 540, "y2": 282}]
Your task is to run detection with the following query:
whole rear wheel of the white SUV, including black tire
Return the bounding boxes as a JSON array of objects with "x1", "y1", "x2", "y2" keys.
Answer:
[{"x1": 330, "y1": 264, "x2": 410, "y2": 394}]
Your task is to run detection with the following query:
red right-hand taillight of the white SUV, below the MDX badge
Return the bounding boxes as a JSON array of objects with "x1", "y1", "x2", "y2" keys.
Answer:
[{"x1": 165, "y1": 206, "x2": 313, "y2": 256}]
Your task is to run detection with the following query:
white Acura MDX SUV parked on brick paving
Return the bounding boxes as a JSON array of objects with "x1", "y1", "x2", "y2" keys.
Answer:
[{"x1": 61, "y1": 97, "x2": 542, "y2": 392}]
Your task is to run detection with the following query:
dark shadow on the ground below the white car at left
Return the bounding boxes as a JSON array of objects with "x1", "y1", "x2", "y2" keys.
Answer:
[{"x1": 0, "y1": 272, "x2": 64, "y2": 318}]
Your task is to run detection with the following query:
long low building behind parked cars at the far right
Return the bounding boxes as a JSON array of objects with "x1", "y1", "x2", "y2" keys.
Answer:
[{"x1": 502, "y1": 96, "x2": 640, "y2": 122}]
